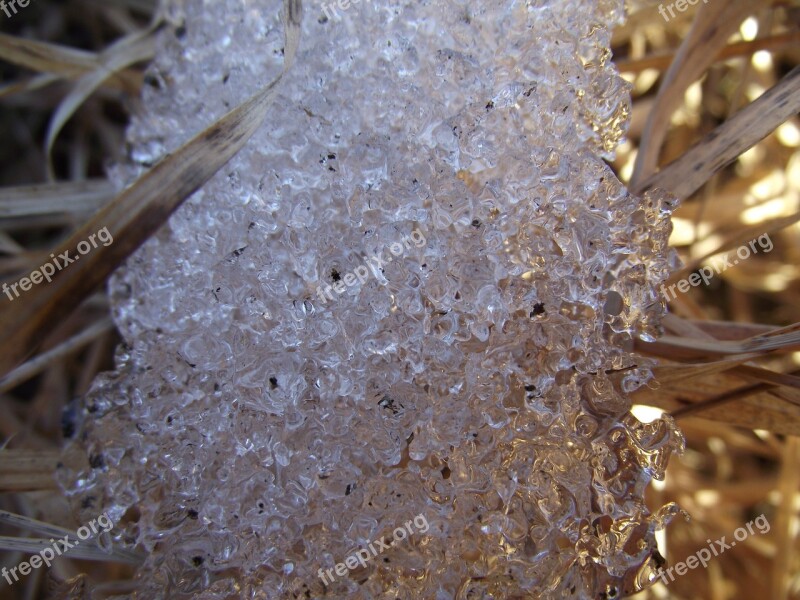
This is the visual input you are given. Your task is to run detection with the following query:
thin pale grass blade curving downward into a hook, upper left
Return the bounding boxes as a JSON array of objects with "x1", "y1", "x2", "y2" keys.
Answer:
[{"x1": 45, "y1": 28, "x2": 157, "y2": 180}]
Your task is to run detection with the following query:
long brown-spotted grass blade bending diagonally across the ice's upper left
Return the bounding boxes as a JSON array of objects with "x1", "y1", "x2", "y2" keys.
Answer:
[{"x1": 0, "y1": 0, "x2": 302, "y2": 373}]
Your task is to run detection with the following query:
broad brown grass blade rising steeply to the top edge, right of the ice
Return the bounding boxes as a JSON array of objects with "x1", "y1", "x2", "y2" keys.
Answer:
[{"x1": 631, "y1": 0, "x2": 769, "y2": 190}]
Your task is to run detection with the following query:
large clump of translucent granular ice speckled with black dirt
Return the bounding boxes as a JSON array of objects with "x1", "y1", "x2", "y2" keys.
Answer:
[{"x1": 63, "y1": 0, "x2": 681, "y2": 600}]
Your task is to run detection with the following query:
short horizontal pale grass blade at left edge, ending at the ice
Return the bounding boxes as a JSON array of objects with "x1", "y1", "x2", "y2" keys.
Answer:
[{"x1": 0, "y1": 179, "x2": 114, "y2": 219}]
